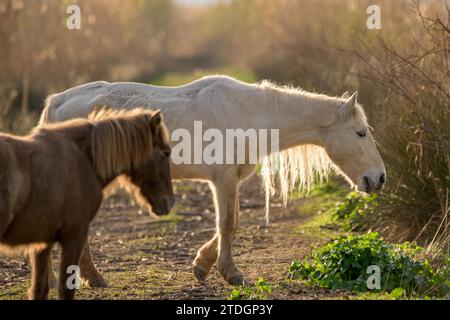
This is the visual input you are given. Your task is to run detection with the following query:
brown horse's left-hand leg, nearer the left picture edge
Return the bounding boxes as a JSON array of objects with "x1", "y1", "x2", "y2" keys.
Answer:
[{"x1": 28, "y1": 245, "x2": 53, "y2": 300}]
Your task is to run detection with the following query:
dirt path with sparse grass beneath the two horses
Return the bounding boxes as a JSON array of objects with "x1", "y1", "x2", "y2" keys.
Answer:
[{"x1": 0, "y1": 177, "x2": 350, "y2": 299}]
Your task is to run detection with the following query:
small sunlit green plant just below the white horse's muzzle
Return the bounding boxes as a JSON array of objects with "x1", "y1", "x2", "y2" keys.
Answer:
[{"x1": 330, "y1": 192, "x2": 377, "y2": 231}]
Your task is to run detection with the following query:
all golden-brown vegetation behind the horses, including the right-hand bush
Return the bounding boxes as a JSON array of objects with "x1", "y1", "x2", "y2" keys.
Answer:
[{"x1": 0, "y1": 0, "x2": 450, "y2": 268}]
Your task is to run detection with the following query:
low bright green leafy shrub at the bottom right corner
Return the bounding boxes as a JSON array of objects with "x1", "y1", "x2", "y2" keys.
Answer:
[{"x1": 289, "y1": 233, "x2": 450, "y2": 296}]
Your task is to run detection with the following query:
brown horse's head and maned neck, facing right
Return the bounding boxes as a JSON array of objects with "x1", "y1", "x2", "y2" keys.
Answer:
[{"x1": 90, "y1": 108, "x2": 175, "y2": 215}]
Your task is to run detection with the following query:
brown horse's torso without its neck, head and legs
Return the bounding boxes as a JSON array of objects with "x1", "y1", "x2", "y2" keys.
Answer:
[{"x1": 0, "y1": 131, "x2": 103, "y2": 245}]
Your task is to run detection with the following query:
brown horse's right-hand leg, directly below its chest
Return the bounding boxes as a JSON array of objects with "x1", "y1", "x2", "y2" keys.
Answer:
[{"x1": 58, "y1": 227, "x2": 87, "y2": 300}]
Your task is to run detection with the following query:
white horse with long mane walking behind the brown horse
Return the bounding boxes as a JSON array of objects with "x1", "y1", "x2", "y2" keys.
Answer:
[{"x1": 41, "y1": 76, "x2": 386, "y2": 286}]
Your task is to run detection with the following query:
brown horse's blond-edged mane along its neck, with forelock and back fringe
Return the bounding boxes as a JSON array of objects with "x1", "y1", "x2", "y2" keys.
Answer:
[{"x1": 37, "y1": 107, "x2": 169, "y2": 180}]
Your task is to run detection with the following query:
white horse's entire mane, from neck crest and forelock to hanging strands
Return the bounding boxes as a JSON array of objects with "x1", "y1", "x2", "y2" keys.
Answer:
[{"x1": 260, "y1": 80, "x2": 369, "y2": 224}]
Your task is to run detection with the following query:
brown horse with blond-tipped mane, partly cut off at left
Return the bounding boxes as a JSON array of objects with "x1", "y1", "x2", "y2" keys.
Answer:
[{"x1": 0, "y1": 109, "x2": 174, "y2": 299}]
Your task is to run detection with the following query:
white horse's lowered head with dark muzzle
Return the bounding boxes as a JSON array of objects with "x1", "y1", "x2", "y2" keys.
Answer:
[{"x1": 323, "y1": 92, "x2": 386, "y2": 193}]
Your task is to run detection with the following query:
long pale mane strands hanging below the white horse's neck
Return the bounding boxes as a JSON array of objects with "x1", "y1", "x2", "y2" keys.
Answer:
[{"x1": 261, "y1": 144, "x2": 334, "y2": 225}]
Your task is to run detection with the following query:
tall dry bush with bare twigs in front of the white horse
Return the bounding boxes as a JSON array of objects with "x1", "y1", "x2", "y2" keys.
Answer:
[{"x1": 356, "y1": 2, "x2": 450, "y2": 248}]
